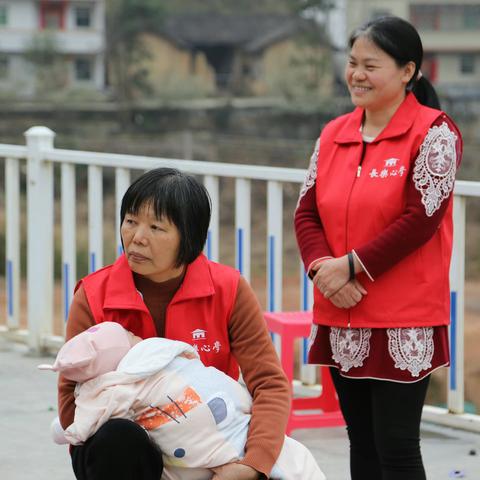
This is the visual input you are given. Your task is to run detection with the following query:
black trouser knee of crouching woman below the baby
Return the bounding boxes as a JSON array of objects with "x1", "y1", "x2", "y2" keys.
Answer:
[{"x1": 71, "y1": 418, "x2": 163, "y2": 480}]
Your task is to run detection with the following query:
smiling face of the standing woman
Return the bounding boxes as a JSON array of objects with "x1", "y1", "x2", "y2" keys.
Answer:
[{"x1": 345, "y1": 37, "x2": 415, "y2": 112}]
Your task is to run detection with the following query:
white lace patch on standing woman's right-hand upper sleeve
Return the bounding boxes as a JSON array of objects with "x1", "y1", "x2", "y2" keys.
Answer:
[{"x1": 413, "y1": 122, "x2": 457, "y2": 217}]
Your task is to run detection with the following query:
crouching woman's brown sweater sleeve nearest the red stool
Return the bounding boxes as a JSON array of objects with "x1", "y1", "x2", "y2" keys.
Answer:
[{"x1": 229, "y1": 278, "x2": 290, "y2": 477}]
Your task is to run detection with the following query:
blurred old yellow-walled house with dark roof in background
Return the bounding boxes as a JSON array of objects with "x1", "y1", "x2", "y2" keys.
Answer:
[{"x1": 133, "y1": 13, "x2": 333, "y2": 97}]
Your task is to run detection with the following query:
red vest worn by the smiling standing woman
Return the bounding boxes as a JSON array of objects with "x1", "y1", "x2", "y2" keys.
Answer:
[{"x1": 314, "y1": 94, "x2": 452, "y2": 328}]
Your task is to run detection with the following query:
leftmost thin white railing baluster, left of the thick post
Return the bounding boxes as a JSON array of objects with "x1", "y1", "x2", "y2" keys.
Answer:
[{"x1": 5, "y1": 158, "x2": 20, "y2": 329}]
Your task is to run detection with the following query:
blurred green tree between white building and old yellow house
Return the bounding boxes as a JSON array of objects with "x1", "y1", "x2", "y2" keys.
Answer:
[{"x1": 107, "y1": 0, "x2": 165, "y2": 102}]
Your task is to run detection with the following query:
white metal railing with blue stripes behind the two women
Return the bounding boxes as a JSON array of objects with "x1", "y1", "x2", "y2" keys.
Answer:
[{"x1": 0, "y1": 127, "x2": 480, "y2": 431}]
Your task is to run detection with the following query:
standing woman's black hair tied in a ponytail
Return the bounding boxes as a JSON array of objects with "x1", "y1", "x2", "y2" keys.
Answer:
[{"x1": 348, "y1": 16, "x2": 440, "y2": 109}]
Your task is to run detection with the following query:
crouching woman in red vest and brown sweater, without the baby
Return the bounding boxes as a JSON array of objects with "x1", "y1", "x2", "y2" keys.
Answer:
[{"x1": 58, "y1": 168, "x2": 290, "y2": 480}]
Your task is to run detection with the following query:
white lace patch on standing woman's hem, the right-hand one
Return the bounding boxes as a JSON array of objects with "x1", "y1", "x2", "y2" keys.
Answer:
[{"x1": 387, "y1": 327, "x2": 434, "y2": 377}]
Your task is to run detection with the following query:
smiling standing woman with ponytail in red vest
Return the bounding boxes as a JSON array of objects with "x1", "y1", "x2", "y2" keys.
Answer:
[{"x1": 295, "y1": 17, "x2": 462, "y2": 480}]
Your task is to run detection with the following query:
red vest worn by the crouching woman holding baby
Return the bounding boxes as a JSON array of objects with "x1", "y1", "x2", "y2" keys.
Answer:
[{"x1": 77, "y1": 254, "x2": 240, "y2": 379}]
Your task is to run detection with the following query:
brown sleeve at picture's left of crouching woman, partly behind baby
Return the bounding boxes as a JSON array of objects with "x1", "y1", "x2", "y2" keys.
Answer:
[{"x1": 58, "y1": 286, "x2": 95, "y2": 429}]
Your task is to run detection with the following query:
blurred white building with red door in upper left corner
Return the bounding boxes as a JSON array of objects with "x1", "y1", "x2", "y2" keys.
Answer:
[{"x1": 0, "y1": 0, "x2": 105, "y2": 96}]
